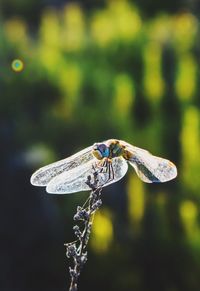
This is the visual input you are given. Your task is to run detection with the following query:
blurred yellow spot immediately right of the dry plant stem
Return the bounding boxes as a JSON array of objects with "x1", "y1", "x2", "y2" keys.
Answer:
[{"x1": 90, "y1": 209, "x2": 113, "y2": 253}]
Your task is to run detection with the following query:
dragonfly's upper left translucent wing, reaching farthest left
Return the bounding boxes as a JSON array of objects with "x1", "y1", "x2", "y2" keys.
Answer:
[{"x1": 31, "y1": 146, "x2": 94, "y2": 186}]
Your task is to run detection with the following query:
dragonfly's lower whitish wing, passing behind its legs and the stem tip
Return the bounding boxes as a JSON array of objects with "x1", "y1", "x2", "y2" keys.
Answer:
[{"x1": 46, "y1": 158, "x2": 128, "y2": 194}]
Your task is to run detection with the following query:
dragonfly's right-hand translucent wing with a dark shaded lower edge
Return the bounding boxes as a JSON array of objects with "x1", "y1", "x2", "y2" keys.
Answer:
[{"x1": 123, "y1": 142, "x2": 177, "y2": 183}]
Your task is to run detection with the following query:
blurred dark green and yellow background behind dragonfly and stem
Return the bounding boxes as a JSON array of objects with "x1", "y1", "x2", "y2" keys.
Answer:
[{"x1": 0, "y1": 0, "x2": 200, "y2": 291}]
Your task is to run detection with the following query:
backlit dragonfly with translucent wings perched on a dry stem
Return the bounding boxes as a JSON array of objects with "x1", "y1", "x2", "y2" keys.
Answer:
[{"x1": 30, "y1": 139, "x2": 177, "y2": 194}]
